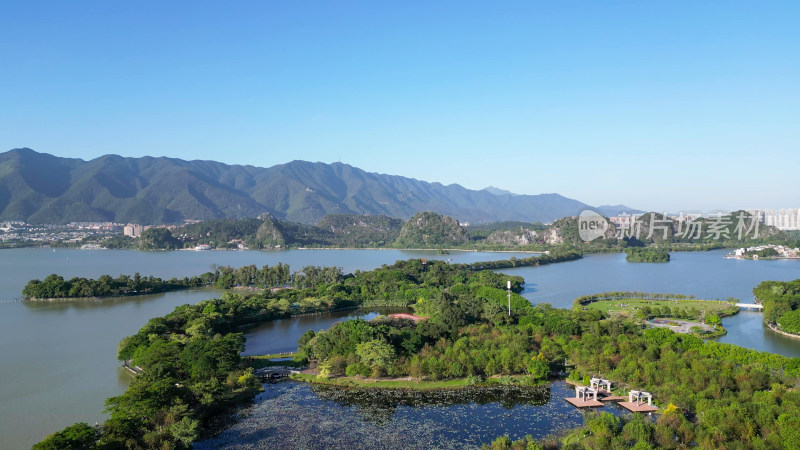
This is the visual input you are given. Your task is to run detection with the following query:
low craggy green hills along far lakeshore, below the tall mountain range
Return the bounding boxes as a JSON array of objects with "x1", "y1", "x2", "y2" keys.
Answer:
[{"x1": 120, "y1": 211, "x2": 796, "y2": 251}]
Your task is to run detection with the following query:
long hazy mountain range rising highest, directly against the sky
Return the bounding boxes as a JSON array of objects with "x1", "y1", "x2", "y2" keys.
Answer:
[{"x1": 0, "y1": 148, "x2": 636, "y2": 225}]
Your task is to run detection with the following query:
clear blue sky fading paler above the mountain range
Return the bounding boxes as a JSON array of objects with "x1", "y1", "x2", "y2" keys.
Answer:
[{"x1": 0, "y1": 1, "x2": 800, "y2": 211}]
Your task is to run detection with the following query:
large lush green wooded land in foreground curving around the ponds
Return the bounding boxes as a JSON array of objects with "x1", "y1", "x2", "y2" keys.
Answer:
[{"x1": 37, "y1": 255, "x2": 800, "y2": 448}]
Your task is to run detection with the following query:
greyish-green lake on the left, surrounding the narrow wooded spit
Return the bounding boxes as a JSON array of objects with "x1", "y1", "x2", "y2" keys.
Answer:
[{"x1": 0, "y1": 249, "x2": 527, "y2": 449}]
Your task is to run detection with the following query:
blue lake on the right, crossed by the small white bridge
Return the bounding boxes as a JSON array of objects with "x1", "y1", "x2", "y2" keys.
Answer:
[{"x1": 503, "y1": 250, "x2": 800, "y2": 357}]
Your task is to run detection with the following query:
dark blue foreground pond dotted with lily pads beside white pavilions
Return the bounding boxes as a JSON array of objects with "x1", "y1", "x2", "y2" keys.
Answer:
[{"x1": 195, "y1": 381, "x2": 626, "y2": 449}]
